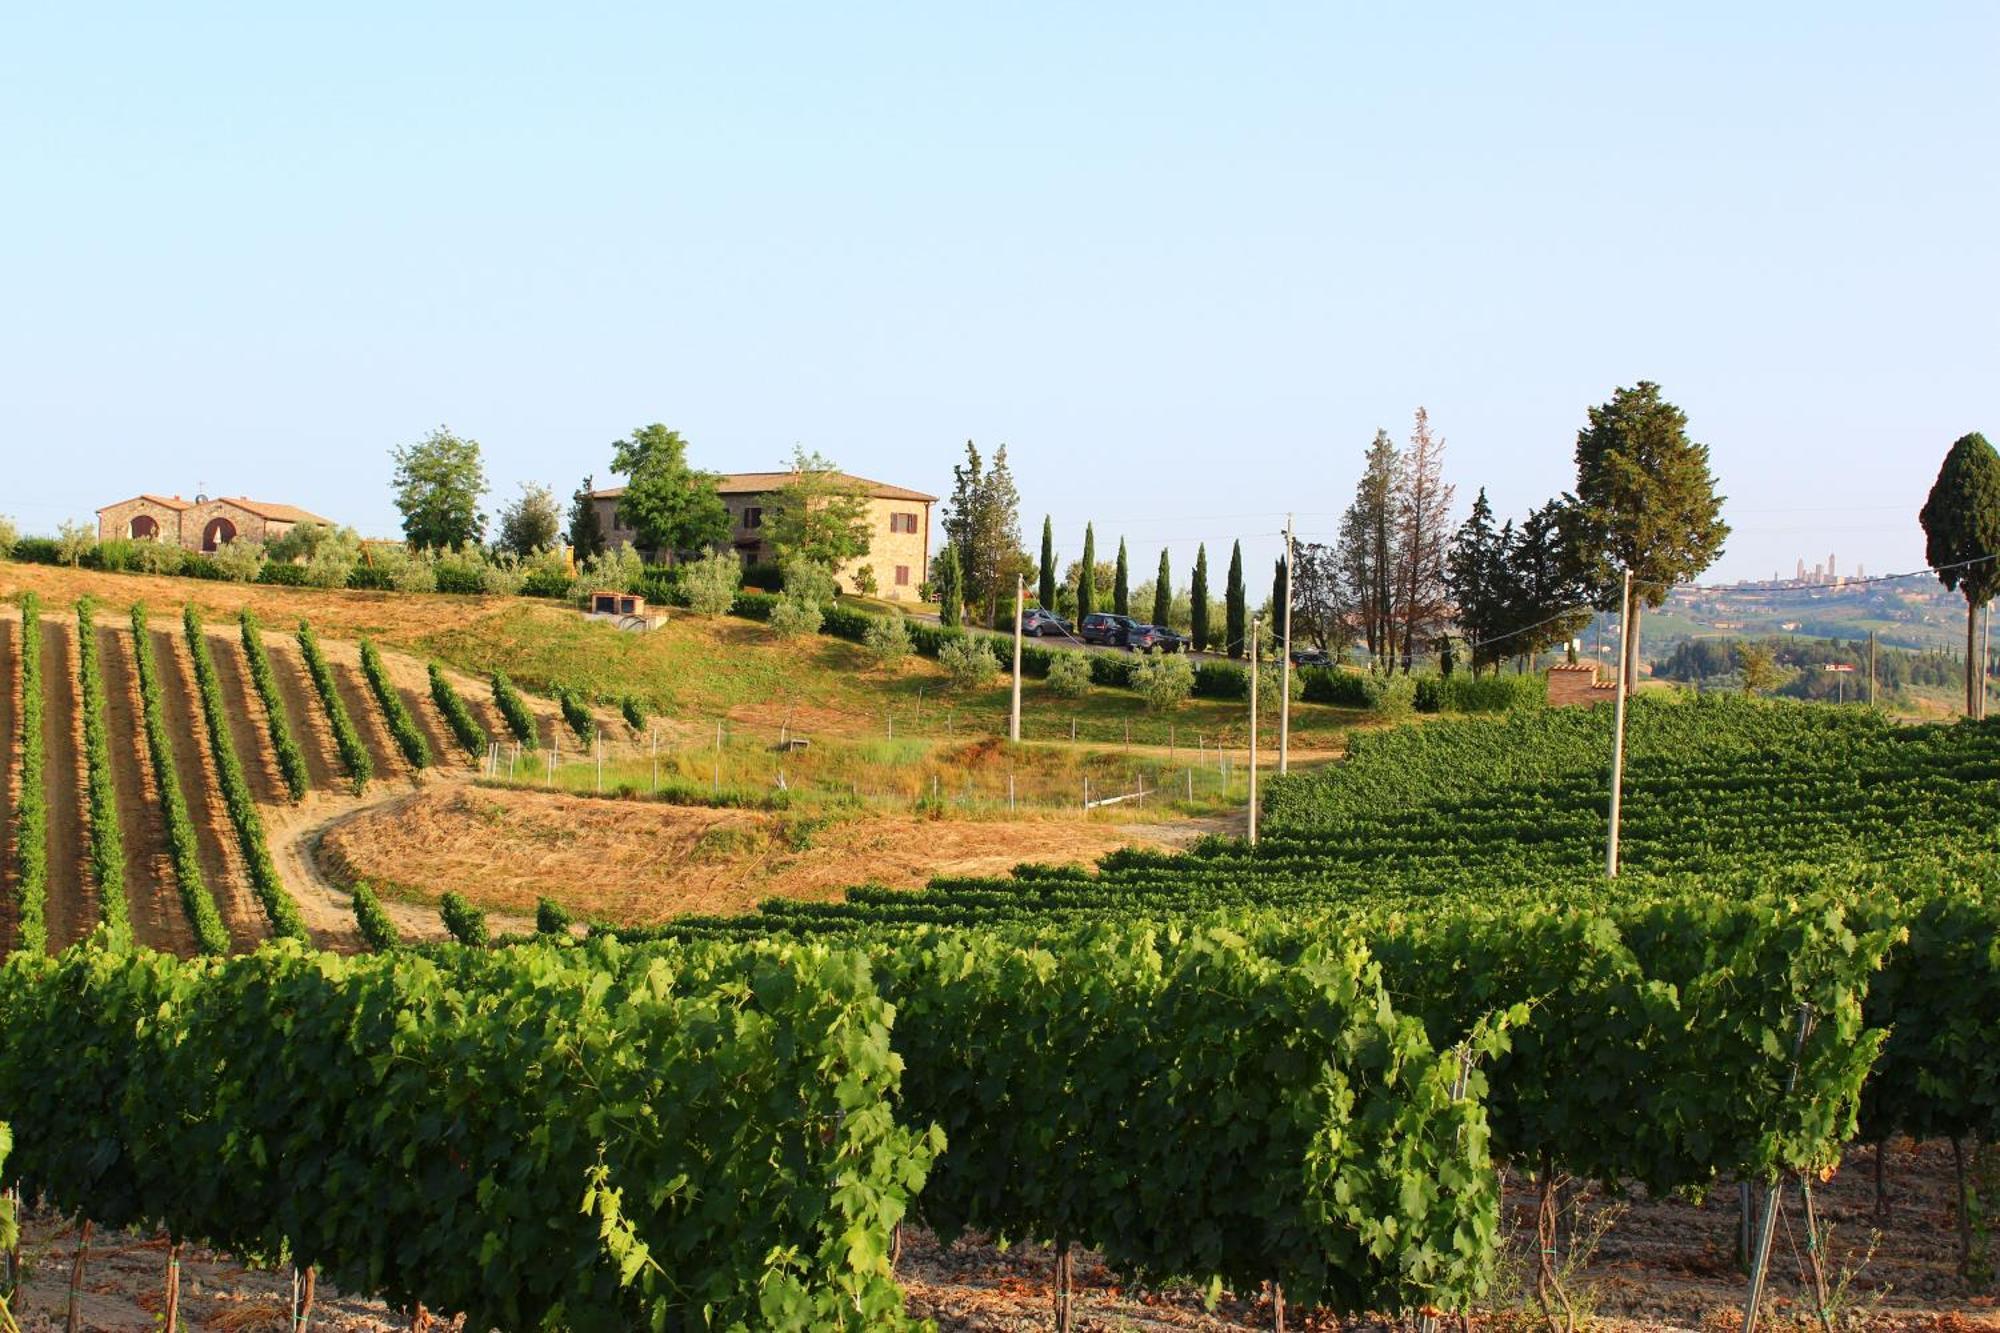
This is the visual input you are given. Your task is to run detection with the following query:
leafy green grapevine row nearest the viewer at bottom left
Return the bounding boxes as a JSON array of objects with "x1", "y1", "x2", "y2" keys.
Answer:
[{"x1": 0, "y1": 928, "x2": 940, "y2": 1333}]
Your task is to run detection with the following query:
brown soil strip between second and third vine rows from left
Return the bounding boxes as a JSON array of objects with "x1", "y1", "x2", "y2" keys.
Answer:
[{"x1": 98, "y1": 624, "x2": 194, "y2": 957}]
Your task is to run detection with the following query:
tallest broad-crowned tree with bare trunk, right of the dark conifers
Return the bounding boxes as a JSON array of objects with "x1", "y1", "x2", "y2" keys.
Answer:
[{"x1": 1574, "y1": 380, "x2": 1730, "y2": 689}]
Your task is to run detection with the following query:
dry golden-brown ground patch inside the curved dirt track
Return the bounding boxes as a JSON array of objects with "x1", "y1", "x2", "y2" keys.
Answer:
[{"x1": 320, "y1": 785, "x2": 1158, "y2": 929}]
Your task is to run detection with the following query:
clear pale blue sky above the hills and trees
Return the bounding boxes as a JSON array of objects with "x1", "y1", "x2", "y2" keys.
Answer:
[{"x1": 0, "y1": 0, "x2": 2000, "y2": 586}]
